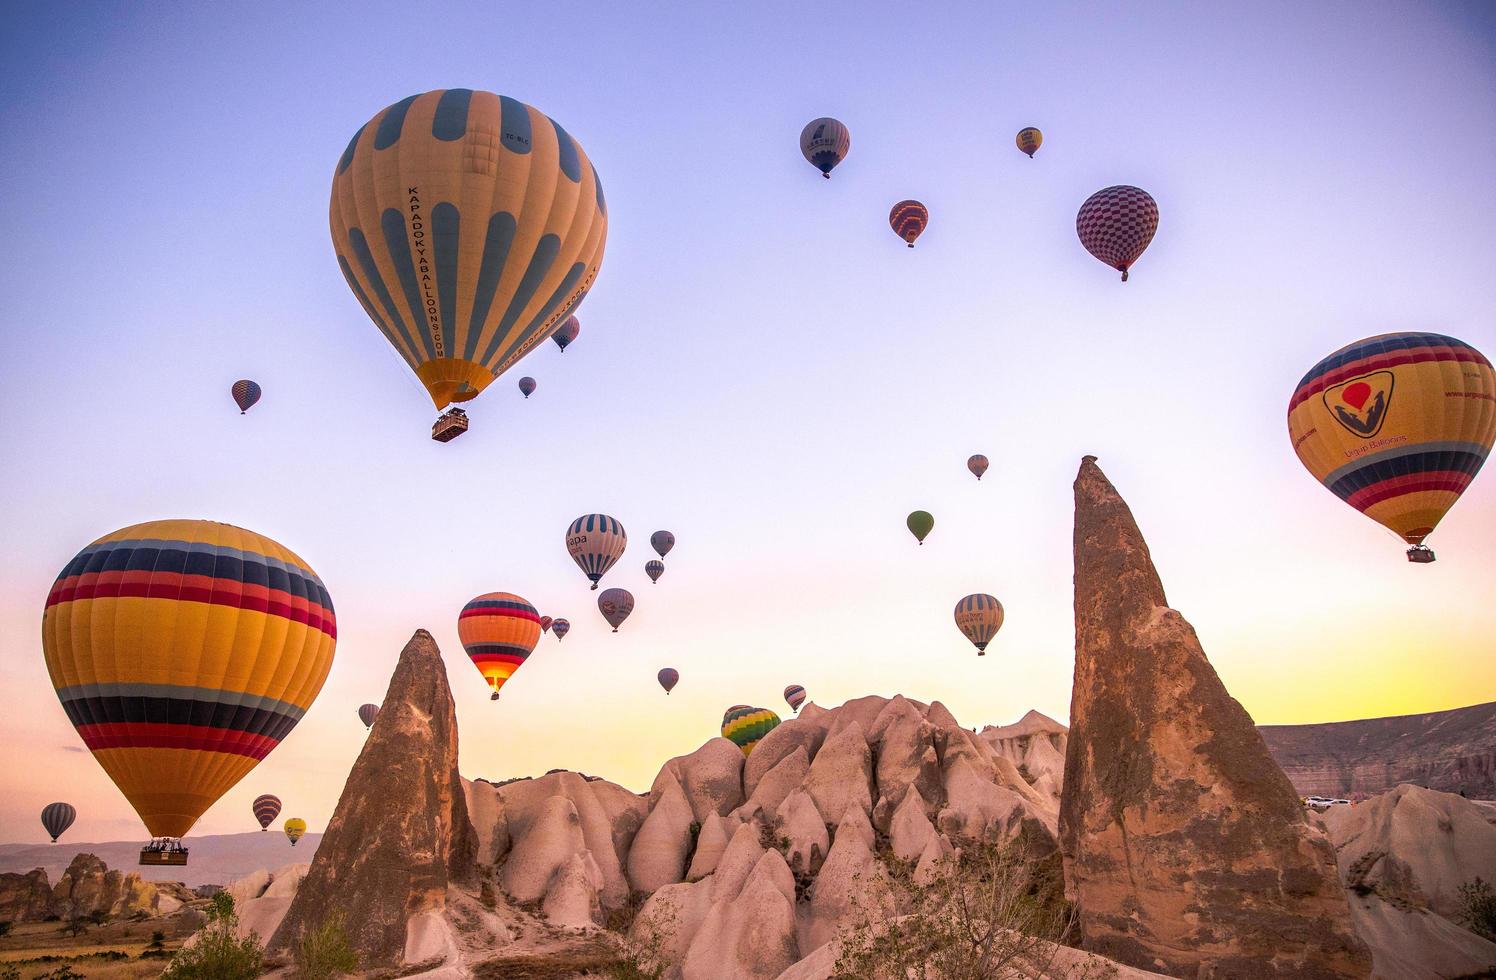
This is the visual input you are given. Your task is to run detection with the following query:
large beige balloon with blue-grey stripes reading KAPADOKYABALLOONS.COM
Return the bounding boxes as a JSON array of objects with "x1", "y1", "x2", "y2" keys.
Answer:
[{"x1": 331, "y1": 88, "x2": 607, "y2": 439}]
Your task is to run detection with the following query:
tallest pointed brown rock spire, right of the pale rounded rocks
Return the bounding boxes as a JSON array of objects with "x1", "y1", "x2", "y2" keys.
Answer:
[{"x1": 1059, "y1": 456, "x2": 1370, "y2": 979}]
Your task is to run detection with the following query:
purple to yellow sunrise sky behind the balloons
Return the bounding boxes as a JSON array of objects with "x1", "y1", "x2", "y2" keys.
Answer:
[{"x1": 0, "y1": 1, "x2": 1496, "y2": 841}]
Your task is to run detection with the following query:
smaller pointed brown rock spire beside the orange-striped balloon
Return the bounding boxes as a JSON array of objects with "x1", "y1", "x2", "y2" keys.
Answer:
[{"x1": 271, "y1": 630, "x2": 477, "y2": 968}]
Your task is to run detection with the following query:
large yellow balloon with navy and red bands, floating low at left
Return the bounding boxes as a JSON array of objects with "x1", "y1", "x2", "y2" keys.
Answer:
[{"x1": 42, "y1": 521, "x2": 338, "y2": 865}]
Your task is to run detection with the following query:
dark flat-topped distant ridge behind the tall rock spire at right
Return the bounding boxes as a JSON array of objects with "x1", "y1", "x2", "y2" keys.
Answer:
[{"x1": 1258, "y1": 702, "x2": 1496, "y2": 799}]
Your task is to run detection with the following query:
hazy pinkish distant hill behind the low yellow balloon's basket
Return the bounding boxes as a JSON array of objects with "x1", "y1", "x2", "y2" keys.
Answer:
[{"x1": 0, "y1": 830, "x2": 322, "y2": 887}]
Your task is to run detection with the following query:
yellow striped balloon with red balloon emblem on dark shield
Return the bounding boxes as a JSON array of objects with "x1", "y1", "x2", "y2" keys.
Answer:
[{"x1": 1288, "y1": 334, "x2": 1496, "y2": 564}]
